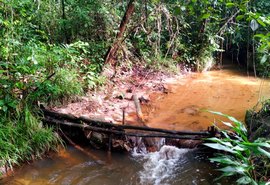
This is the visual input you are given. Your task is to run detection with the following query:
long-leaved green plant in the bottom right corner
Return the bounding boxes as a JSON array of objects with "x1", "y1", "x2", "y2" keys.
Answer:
[{"x1": 204, "y1": 111, "x2": 270, "y2": 185}]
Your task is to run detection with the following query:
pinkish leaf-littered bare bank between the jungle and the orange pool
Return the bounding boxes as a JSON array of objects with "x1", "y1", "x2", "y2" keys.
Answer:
[{"x1": 51, "y1": 66, "x2": 181, "y2": 125}]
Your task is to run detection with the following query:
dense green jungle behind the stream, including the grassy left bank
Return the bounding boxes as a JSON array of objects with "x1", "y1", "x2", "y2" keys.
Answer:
[{"x1": 0, "y1": 0, "x2": 270, "y2": 182}]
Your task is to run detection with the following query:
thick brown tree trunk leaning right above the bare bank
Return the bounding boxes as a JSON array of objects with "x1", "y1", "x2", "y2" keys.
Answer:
[{"x1": 105, "y1": 0, "x2": 135, "y2": 70}]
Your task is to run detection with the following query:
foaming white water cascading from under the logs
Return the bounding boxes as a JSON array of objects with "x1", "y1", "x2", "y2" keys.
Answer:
[{"x1": 132, "y1": 139, "x2": 189, "y2": 185}]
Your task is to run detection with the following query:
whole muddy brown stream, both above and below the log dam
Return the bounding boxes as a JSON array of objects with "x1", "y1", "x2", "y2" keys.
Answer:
[{"x1": 0, "y1": 64, "x2": 270, "y2": 185}]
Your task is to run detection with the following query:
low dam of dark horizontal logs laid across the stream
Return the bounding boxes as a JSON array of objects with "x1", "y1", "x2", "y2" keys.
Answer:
[{"x1": 42, "y1": 109, "x2": 217, "y2": 151}]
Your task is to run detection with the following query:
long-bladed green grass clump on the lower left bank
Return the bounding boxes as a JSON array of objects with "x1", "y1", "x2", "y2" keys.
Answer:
[{"x1": 0, "y1": 107, "x2": 61, "y2": 173}]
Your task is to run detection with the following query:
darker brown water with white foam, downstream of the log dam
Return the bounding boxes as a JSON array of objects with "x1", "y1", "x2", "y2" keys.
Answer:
[{"x1": 3, "y1": 146, "x2": 233, "y2": 185}]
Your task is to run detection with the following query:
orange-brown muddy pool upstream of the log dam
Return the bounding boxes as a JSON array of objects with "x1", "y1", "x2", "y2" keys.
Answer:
[{"x1": 147, "y1": 65, "x2": 270, "y2": 131}]
